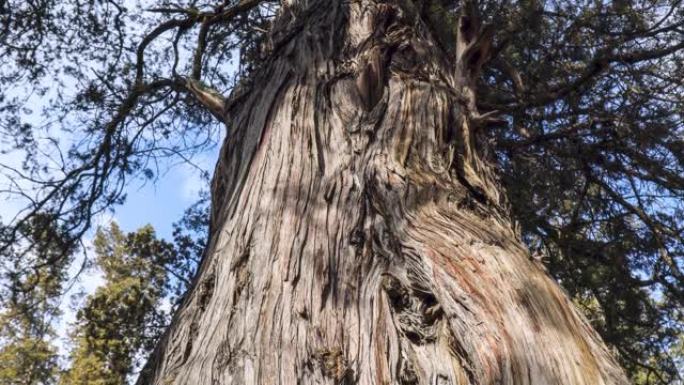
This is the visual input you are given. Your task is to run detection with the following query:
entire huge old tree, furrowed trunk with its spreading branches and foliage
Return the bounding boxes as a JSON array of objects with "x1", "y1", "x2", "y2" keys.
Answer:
[{"x1": 0, "y1": 0, "x2": 684, "y2": 384}]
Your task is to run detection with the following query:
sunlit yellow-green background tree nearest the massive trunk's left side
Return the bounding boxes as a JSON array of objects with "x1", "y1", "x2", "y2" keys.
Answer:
[{"x1": 61, "y1": 223, "x2": 174, "y2": 385}]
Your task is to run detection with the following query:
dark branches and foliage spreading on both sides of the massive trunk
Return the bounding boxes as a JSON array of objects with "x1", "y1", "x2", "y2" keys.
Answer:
[{"x1": 0, "y1": 0, "x2": 684, "y2": 384}]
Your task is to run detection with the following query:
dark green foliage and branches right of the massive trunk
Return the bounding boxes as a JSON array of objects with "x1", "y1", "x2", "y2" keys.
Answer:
[{"x1": 480, "y1": 1, "x2": 684, "y2": 384}]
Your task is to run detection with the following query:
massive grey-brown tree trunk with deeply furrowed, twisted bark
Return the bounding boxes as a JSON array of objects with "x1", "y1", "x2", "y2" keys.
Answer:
[{"x1": 139, "y1": 0, "x2": 627, "y2": 385}]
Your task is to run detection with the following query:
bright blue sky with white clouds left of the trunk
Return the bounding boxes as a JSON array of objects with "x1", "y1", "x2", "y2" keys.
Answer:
[{"x1": 0, "y1": 0, "x2": 239, "y2": 366}]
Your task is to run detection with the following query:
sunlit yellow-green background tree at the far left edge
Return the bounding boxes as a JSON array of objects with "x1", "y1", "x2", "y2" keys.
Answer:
[{"x1": 0, "y1": 216, "x2": 69, "y2": 385}]
